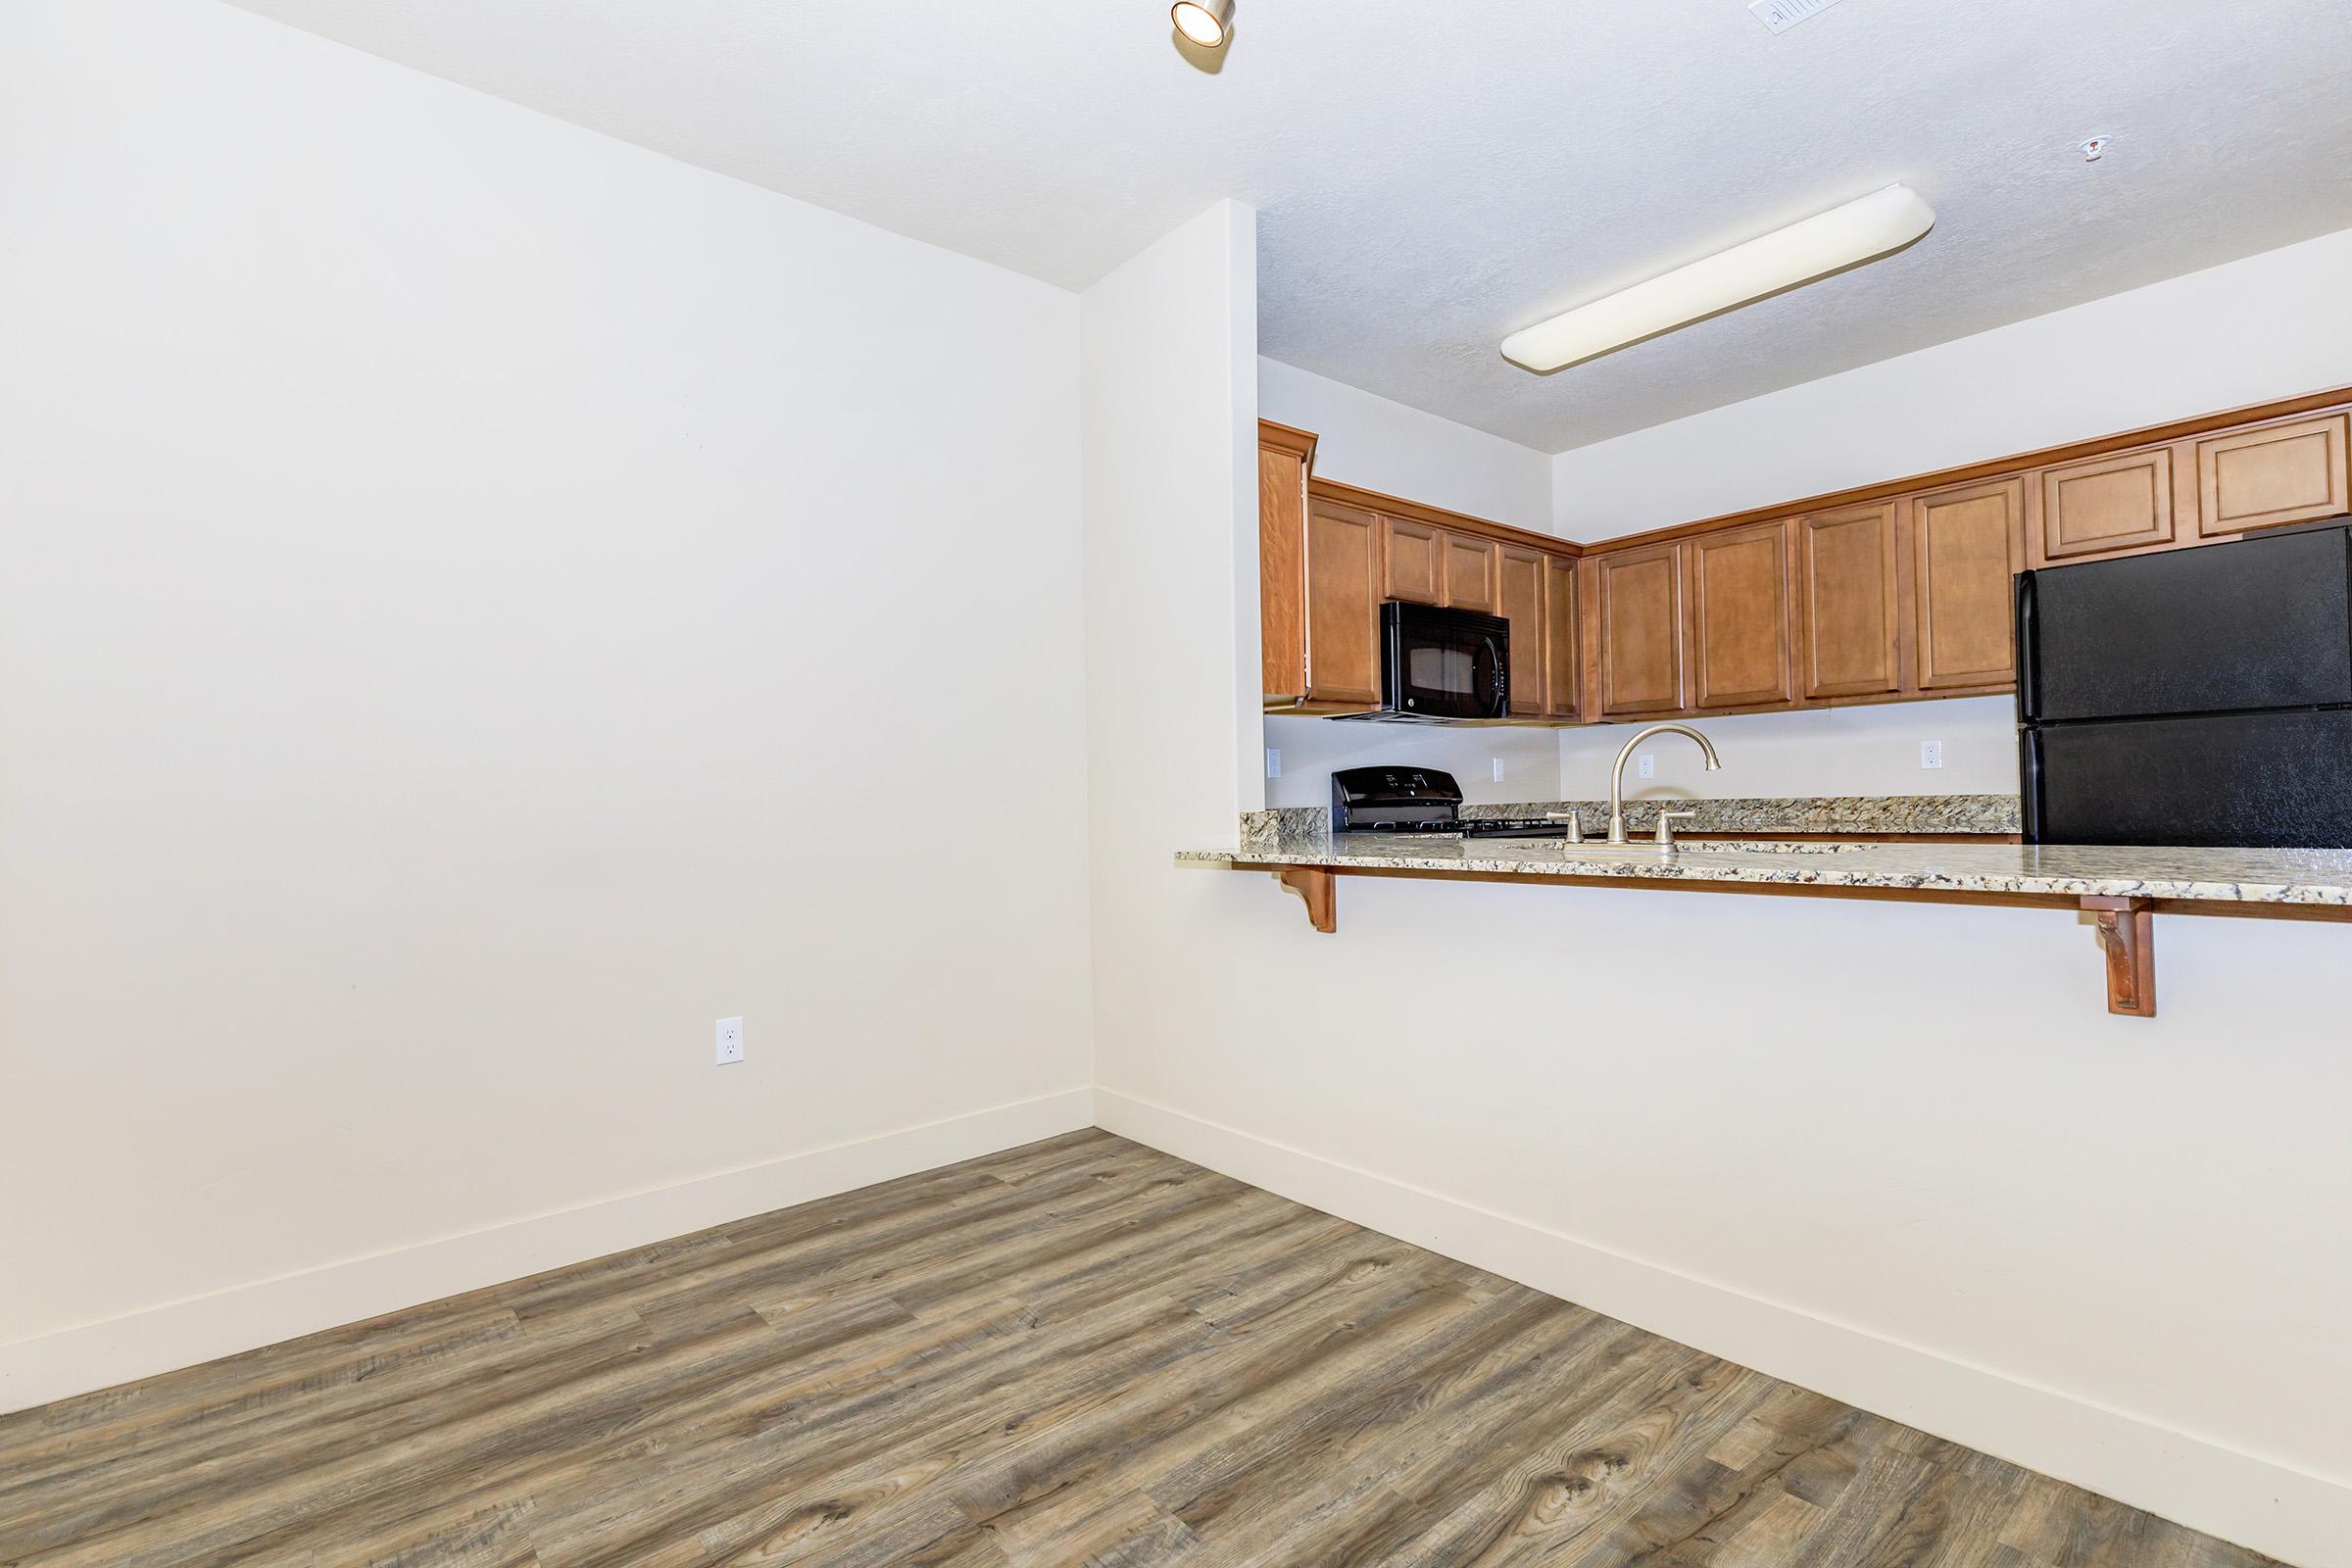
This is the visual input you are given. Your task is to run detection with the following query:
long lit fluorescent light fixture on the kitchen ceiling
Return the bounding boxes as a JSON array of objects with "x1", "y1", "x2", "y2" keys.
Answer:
[{"x1": 1503, "y1": 186, "x2": 1936, "y2": 371}]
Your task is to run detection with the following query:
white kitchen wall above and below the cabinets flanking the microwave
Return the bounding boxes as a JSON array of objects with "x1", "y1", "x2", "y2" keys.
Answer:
[{"x1": 1245, "y1": 358, "x2": 1559, "y2": 807}]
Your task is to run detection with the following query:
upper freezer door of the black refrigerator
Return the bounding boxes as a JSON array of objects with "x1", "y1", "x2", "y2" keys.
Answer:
[{"x1": 2018, "y1": 526, "x2": 2352, "y2": 721}]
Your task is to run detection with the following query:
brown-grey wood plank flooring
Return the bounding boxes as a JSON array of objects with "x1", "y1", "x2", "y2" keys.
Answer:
[{"x1": 0, "y1": 1133, "x2": 2270, "y2": 1568}]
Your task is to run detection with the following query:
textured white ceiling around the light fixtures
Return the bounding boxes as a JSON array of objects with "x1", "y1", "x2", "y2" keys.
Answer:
[{"x1": 216, "y1": 0, "x2": 2352, "y2": 452}]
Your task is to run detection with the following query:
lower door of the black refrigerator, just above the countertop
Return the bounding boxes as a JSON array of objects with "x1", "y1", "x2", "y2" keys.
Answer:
[{"x1": 2023, "y1": 710, "x2": 2352, "y2": 849}]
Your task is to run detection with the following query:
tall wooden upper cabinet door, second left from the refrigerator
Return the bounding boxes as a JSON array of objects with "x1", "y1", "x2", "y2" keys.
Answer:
[{"x1": 1797, "y1": 501, "x2": 1903, "y2": 698}]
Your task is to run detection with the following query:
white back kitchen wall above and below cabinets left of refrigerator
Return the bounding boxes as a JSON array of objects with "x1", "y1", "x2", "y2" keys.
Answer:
[{"x1": 1552, "y1": 230, "x2": 2352, "y2": 797}]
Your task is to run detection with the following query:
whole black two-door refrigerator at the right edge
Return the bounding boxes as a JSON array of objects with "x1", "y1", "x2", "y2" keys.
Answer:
[{"x1": 2018, "y1": 517, "x2": 2352, "y2": 849}]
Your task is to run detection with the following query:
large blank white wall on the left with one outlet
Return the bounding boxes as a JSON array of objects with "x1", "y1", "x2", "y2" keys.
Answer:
[{"x1": 0, "y1": 0, "x2": 1096, "y2": 1405}]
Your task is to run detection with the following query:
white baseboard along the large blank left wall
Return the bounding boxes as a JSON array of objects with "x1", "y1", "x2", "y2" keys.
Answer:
[{"x1": 0, "y1": 1089, "x2": 1094, "y2": 1413}]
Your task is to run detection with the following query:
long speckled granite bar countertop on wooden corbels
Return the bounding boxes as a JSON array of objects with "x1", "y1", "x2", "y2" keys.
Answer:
[{"x1": 1176, "y1": 832, "x2": 2352, "y2": 906}]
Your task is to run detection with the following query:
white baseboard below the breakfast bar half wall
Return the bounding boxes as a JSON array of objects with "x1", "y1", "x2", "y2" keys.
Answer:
[{"x1": 1094, "y1": 1086, "x2": 2352, "y2": 1568}]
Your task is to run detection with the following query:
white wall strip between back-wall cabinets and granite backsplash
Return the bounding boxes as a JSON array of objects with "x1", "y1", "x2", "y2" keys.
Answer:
[{"x1": 1552, "y1": 696, "x2": 2018, "y2": 800}]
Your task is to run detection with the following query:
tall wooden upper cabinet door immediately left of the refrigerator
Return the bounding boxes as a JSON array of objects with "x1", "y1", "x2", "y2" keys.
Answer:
[{"x1": 1910, "y1": 479, "x2": 2025, "y2": 691}]
